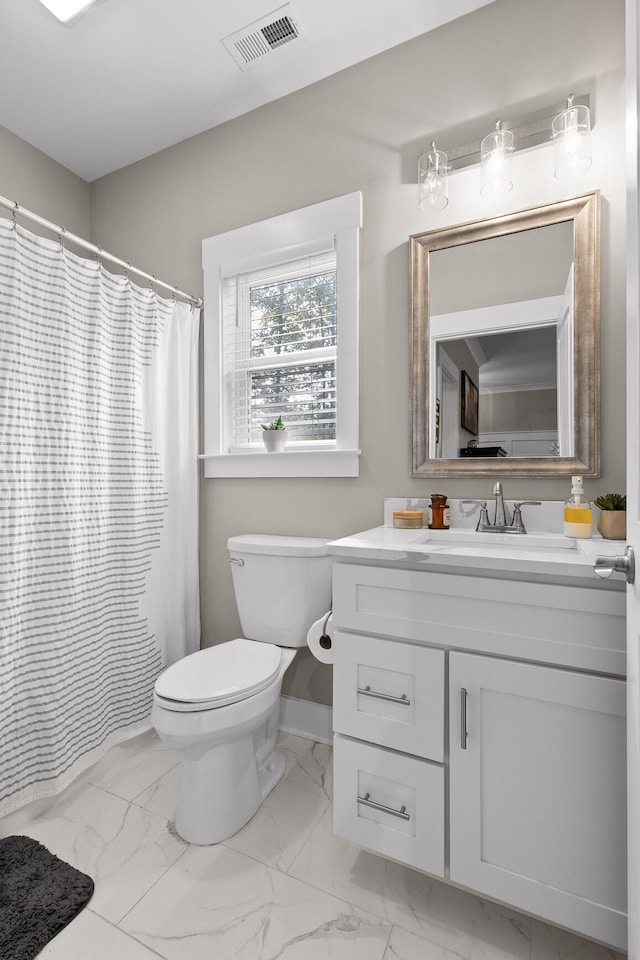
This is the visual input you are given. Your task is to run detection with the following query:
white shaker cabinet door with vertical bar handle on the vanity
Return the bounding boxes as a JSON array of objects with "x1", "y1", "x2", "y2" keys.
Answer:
[{"x1": 450, "y1": 653, "x2": 627, "y2": 949}]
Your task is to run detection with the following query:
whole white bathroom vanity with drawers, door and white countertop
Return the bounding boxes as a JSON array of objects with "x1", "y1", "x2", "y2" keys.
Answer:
[{"x1": 329, "y1": 527, "x2": 627, "y2": 950}]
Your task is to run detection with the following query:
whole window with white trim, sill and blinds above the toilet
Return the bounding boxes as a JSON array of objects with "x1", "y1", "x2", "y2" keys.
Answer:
[{"x1": 203, "y1": 193, "x2": 362, "y2": 477}]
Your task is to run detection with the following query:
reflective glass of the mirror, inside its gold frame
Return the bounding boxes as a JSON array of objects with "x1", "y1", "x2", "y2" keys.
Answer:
[{"x1": 429, "y1": 221, "x2": 574, "y2": 459}]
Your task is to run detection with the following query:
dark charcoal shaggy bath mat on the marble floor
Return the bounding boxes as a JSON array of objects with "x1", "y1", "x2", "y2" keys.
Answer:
[{"x1": 0, "y1": 837, "x2": 93, "y2": 960}]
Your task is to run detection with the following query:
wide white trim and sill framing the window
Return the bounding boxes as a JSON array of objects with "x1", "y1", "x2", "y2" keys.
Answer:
[{"x1": 201, "y1": 192, "x2": 362, "y2": 477}]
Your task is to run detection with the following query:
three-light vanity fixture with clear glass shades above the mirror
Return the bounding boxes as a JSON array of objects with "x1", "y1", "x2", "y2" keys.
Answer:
[{"x1": 418, "y1": 94, "x2": 593, "y2": 213}]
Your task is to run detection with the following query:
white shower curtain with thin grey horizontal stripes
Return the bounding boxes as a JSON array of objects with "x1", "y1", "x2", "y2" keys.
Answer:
[{"x1": 0, "y1": 220, "x2": 200, "y2": 815}]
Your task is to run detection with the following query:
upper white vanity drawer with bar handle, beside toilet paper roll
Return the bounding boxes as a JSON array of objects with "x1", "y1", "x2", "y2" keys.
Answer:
[{"x1": 333, "y1": 631, "x2": 444, "y2": 762}]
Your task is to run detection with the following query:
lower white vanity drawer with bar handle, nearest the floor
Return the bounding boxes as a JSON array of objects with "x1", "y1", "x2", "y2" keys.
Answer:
[{"x1": 334, "y1": 735, "x2": 444, "y2": 877}]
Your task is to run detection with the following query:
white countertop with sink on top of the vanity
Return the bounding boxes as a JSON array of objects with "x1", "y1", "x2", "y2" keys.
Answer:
[{"x1": 328, "y1": 526, "x2": 626, "y2": 590}]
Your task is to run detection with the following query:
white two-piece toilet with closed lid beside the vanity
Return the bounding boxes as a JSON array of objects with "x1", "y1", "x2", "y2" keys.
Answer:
[{"x1": 151, "y1": 534, "x2": 332, "y2": 844}]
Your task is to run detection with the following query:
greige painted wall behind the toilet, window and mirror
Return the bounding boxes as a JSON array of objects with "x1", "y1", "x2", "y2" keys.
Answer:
[{"x1": 57, "y1": 0, "x2": 625, "y2": 702}]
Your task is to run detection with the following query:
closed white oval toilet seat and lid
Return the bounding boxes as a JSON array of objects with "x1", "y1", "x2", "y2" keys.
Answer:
[{"x1": 155, "y1": 637, "x2": 282, "y2": 712}]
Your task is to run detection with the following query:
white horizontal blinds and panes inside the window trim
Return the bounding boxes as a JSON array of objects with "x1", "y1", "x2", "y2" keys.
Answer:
[{"x1": 222, "y1": 250, "x2": 338, "y2": 452}]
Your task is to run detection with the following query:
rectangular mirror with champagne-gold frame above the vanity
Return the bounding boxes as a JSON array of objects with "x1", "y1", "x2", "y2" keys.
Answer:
[{"x1": 410, "y1": 191, "x2": 600, "y2": 477}]
